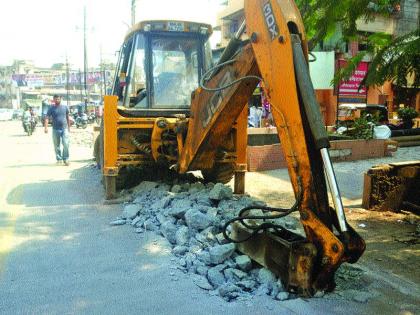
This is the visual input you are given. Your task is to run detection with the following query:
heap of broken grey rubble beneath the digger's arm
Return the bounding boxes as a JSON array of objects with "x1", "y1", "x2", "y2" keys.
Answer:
[{"x1": 110, "y1": 181, "x2": 298, "y2": 301}]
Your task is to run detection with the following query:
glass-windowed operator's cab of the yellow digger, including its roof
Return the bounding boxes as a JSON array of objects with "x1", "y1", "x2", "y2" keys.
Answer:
[{"x1": 113, "y1": 21, "x2": 212, "y2": 117}]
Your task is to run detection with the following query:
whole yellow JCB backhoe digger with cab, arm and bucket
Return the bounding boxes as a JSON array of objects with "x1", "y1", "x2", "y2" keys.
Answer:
[{"x1": 98, "y1": 0, "x2": 365, "y2": 296}]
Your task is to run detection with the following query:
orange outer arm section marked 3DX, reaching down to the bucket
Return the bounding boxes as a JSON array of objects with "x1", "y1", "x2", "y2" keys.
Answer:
[{"x1": 220, "y1": 0, "x2": 365, "y2": 292}]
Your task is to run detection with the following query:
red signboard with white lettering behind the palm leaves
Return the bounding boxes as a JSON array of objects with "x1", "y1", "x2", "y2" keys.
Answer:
[{"x1": 338, "y1": 60, "x2": 369, "y2": 97}]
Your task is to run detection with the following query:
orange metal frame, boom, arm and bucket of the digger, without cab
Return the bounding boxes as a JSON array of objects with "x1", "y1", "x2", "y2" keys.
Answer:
[{"x1": 100, "y1": 0, "x2": 365, "y2": 295}]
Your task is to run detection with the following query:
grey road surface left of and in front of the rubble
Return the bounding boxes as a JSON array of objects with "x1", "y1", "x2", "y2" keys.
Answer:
[{"x1": 0, "y1": 122, "x2": 419, "y2": 315}]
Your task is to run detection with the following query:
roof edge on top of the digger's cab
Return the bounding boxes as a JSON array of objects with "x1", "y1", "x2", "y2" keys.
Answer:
[{"x1": 124, "y1": 20, "x2": 213, "y2": 42}]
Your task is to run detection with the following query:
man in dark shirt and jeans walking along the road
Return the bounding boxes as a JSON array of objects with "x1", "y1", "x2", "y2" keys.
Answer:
[{"x1": 44, "y1": 95, "x2": 70, "y2": 166}]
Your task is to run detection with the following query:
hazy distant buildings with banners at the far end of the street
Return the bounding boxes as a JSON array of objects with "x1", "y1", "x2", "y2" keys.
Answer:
[{"x1": 0, "y1": 60, "x2": 114, "y2": 109}]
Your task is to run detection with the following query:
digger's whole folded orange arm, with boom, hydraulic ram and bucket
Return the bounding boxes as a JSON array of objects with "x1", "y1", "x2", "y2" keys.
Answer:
[{"x1": 178, "y1": 0, "x2": 365, "y2": 295}]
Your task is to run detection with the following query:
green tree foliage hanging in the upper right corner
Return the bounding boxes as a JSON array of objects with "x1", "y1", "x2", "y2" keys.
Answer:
[{"x1": 296, "y1": 0, "x2": 420, "y2": 87}]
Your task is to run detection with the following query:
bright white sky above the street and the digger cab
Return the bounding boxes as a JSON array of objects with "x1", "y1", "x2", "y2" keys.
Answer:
[{"x1": 0, "y1": 0, "x2": 220, "y2": 69}]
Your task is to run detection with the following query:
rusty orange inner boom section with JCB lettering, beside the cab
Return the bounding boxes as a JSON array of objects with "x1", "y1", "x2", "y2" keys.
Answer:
[{"x1": 179, "y1": 44, "x2": 259, "y2": 173}]
